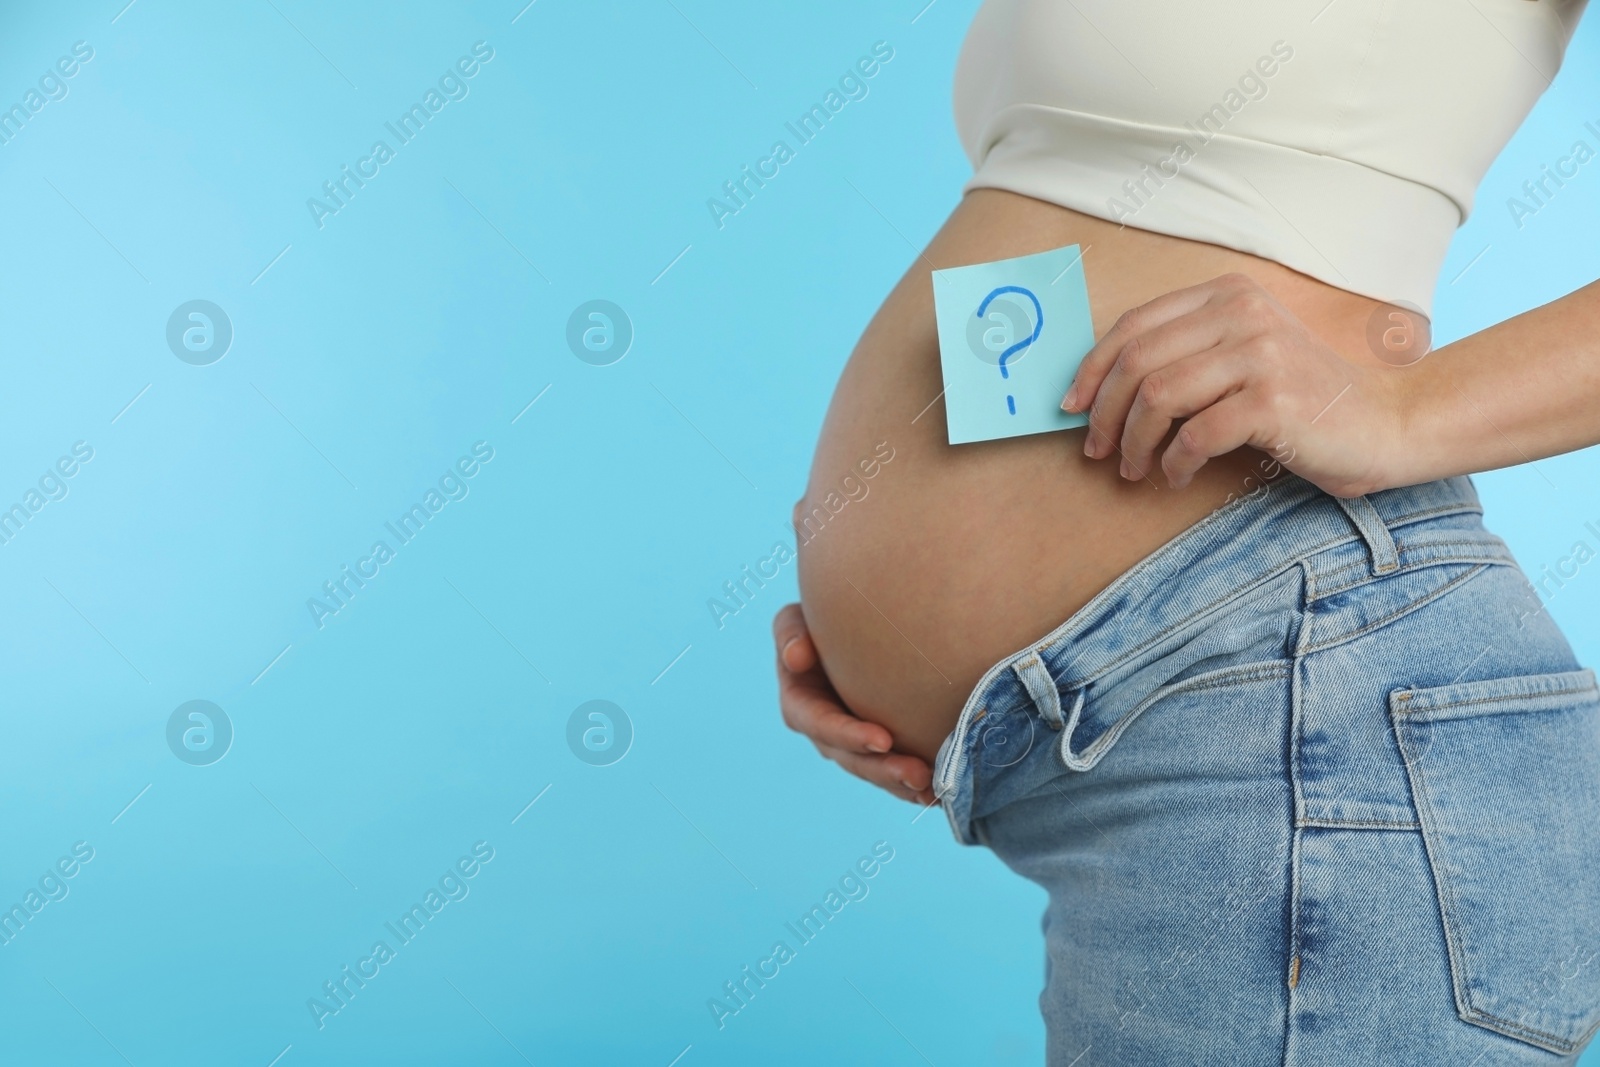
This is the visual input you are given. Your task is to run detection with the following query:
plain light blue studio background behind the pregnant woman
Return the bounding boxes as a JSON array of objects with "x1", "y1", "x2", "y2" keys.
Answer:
[{"x1": 0, "y1": 0, "x2": 1600, "y2": 1067}]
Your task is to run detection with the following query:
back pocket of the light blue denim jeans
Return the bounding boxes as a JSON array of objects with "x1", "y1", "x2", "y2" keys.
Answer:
[{"x1": 1389, "y1": 670, "x2": 1600, "y2": 1054}]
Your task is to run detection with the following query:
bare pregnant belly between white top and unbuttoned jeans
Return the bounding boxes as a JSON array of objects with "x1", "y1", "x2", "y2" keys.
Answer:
[{"x1": 797, "y1": 189, "x2": 1408, "y2": 760}]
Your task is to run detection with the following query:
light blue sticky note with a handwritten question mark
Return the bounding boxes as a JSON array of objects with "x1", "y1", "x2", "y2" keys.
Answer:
[{"x1": 933, "y1": 245, "x2": 1094, "y2": 445}]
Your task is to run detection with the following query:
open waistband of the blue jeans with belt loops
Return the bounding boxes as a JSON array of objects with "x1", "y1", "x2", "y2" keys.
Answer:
[{"x1": 933, "y1": 475, "x2": 1514, "y2": 840}]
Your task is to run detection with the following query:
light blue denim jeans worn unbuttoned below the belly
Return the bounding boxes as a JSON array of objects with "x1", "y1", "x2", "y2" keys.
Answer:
[{"x1": 934, "y1": 475, "x2": 1600, "y2": 1067}]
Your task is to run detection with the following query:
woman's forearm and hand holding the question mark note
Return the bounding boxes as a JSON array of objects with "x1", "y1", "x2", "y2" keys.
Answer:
[{"x1": 1062, "y1": 275, "x2": 1600, "y2": 496}]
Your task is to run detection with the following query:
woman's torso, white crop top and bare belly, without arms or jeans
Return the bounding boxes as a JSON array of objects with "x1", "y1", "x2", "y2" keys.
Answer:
[{"x1": 800, "y1": 0, "x2": 1584, "y2": 767}]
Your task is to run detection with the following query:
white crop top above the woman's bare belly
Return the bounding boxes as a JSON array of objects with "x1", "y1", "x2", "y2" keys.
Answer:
[{"x1": 955, "y1": 0, "x2": 1586, "y2": 315}]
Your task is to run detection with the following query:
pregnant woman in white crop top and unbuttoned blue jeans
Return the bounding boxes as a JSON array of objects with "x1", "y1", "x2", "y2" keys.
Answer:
[{"x1": 774, "y1": 0, "x2": 1600, "y2": 1067}]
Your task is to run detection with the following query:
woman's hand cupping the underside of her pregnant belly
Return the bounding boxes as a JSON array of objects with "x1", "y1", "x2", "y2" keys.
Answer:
[{"x1": 773, "y1": 605, "x2": 933, "y2": 805}]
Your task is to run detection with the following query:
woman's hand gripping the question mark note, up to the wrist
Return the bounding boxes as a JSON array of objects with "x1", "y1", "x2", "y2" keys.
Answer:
[{"x1": 1061, "y1": 274, "x2": 1405, "y2": 496}]
